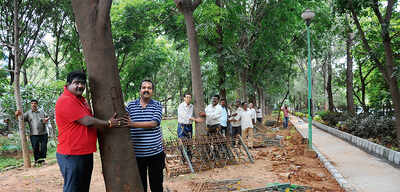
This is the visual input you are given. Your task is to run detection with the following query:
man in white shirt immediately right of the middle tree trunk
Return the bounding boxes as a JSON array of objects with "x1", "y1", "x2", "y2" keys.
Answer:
[{"x1": 205, "y1": 95, "x2": 222, "y2": 136}]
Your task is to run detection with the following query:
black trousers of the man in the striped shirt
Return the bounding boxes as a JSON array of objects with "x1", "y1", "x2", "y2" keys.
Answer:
[{"x1": 136, "y1": 152, "x2": 165, "y2": 192}]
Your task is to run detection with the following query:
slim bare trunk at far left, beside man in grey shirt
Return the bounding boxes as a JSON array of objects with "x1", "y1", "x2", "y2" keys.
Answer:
[{"x1": 14, "y1": 0, "x2": 31, "y2": 168}]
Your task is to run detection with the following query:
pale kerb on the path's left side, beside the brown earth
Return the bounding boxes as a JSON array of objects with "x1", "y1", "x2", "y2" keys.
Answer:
[{"x1": 289, "y1": 120, "x2": 356, "y2": 192}]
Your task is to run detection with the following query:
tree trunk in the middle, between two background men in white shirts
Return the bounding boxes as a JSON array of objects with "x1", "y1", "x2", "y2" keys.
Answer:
[{"x1": 174, "y1": 0, "x2": 206, "y2": 136}]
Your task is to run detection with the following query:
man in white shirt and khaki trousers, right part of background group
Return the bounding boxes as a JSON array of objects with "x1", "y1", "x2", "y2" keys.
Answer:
[{"x1": 240, "y1": 102, "x2": 254, "y2": 148}]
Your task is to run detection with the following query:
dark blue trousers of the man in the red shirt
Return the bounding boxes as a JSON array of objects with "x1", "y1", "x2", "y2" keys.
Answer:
[{"x1": 56, "y1": 153, "x2": 93, "y2": 192}]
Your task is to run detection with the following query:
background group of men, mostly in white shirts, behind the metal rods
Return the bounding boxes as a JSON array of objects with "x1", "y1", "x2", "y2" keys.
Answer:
[{"x1": 177, "y1": 93, "x2": 262, "y2": 148}]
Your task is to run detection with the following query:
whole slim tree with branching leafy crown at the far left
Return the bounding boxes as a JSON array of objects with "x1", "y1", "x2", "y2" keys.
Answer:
[{"x1": 0, "y1": 0, "x2": 55, "y2": 166}]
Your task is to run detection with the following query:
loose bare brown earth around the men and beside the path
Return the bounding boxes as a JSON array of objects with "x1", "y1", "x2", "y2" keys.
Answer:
[{"x1": 0, "y1": 119, "x2": 343, "y2": 192}]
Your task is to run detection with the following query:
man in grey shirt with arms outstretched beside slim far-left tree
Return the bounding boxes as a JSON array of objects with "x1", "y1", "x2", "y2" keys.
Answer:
[{"x1": 15, "y1": 99, "x2": 49, "y2": 165}]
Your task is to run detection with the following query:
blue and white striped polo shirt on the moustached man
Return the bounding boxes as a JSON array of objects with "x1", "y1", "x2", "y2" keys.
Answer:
[{"x1": 126, "y1": 99, "x2": 164, "y2": 157}]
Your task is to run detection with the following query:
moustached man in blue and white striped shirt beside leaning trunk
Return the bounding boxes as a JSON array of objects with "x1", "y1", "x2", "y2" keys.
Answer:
[{"x1": 126, "y1": 80, "x2": 165, "y2": 192}]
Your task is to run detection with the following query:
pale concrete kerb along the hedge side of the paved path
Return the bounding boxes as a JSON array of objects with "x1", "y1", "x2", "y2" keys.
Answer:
[{"x1": 313, "y1": 121, "x2": 400, "y2": 167}]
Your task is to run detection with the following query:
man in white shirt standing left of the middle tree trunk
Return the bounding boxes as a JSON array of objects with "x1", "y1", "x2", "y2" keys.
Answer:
[{"x1": 177, "y1": 93, "x2": 194, "y2": 138}]
